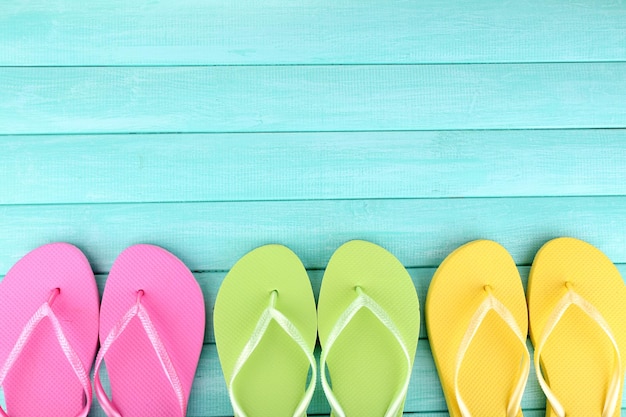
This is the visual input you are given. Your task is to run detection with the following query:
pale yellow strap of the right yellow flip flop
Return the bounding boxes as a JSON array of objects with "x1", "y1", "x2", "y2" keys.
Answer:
[{"x1": 534, "y1": 282, "x2": 622, "y2": 417}]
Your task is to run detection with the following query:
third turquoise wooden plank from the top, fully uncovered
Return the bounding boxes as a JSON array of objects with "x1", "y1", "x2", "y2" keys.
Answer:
[{"x1": 0, "y1": 129, "x2": 626, "y2": 204}]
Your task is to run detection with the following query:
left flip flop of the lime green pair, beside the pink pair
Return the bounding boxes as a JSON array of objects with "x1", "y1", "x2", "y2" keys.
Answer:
[{"x1": 213, "y1": 245, "x2": 317, "y2": 417}]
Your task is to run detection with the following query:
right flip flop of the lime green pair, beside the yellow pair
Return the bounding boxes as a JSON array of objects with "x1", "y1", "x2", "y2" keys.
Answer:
[{"x1": 318, "y1": 240, "x2": 420, "y2": 417}]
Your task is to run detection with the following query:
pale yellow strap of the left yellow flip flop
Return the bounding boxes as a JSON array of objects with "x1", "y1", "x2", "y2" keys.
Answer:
[{"x1": 454, "y1": 285, "x2": 530, "y2": 417}]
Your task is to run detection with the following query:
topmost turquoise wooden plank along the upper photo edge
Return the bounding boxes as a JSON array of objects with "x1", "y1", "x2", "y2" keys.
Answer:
[{"x1": 0, "y1": 0, "x2": 626, "y2": 66}]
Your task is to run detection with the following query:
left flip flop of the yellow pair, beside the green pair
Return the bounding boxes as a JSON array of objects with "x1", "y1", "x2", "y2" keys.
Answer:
[{"x1": 426, "y1": 240, "x2": 530, "y2": 417}]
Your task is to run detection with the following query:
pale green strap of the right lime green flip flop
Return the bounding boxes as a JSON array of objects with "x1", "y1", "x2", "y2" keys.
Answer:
[{"x1": 320, "y1": 287, "x2": 412, "y2": 417}]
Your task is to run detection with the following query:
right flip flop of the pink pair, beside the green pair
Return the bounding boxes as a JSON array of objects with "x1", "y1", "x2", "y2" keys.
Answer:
[{"x1": 94, "y1": 245, "x2": 205, "y2": 417}]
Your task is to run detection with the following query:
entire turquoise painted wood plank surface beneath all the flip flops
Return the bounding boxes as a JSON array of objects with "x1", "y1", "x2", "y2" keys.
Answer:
[{"x1": 0, "y1": 0, "x2": 626, "y2": 417}]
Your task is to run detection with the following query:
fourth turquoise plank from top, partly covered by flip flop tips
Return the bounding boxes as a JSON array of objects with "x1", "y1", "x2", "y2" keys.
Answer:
[{"x1": 0, "y1": 196, "x2": 626, "y2": 273}]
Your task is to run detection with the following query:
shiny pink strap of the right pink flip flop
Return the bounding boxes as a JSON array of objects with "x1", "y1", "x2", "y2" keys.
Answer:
[{"x1": 94, "y1": 290, "x2": 187, "y2": 417}]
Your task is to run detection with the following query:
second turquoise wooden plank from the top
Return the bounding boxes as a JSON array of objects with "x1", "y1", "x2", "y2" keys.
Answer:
[{"x1": 0, "y1": 62, "x2": 626, "y2": 134}]
